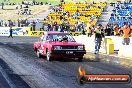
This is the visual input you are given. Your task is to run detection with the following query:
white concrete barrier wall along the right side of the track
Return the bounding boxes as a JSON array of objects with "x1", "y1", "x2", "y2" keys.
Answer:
[{"x1": 74, "y1": 35, "x2": 132, "y2": 58}]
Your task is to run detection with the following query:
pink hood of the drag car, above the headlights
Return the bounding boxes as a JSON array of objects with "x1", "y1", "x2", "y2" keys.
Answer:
[{"x1": 44, "y1": 41, "x2": 83, "y2": 46}]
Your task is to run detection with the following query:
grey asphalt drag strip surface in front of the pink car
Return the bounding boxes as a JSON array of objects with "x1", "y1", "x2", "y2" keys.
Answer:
[{"x1": 0, "y1": 43, "x2": 132, "y2": 88}]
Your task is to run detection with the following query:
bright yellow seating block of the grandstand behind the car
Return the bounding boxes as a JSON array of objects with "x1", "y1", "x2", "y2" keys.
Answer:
[{"x1": 45, "y1": 3, "x2": 107, "y2": 30}]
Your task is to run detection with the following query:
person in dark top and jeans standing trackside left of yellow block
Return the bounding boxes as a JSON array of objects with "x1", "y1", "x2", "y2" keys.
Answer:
[{"x1": 94, "y1": 25, "x2": 102, "y2": 54}]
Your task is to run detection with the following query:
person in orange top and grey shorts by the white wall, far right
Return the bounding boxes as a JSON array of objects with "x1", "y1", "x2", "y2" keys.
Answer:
[{"x1": 121, "y1": 22, "x2": 130, "y2": 45}]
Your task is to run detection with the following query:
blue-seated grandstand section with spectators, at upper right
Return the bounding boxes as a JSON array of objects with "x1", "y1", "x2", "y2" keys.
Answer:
[{"x1": 109, "y1": 3, "x2": 132, "y2": 27}]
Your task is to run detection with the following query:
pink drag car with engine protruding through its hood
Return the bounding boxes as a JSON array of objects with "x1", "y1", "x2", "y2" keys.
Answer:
[{"x1": 33, "y1": 32, "x2": 86, "y2": 61}]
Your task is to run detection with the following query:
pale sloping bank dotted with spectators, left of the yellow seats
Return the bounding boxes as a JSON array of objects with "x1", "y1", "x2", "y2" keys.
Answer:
[{"x1": 0, "y1": 0, "x2": 51, "y2": 28}]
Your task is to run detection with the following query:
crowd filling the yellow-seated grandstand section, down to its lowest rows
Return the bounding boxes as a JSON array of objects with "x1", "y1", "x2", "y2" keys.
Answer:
[{"x1": 42, "y1": 2, "x2": 106, "y2": 32}]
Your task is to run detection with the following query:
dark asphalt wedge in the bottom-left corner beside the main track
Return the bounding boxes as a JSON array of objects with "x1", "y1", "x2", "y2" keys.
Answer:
[{"x1": 0, "y1": 58, "x2": 31, "y2": 88}]
